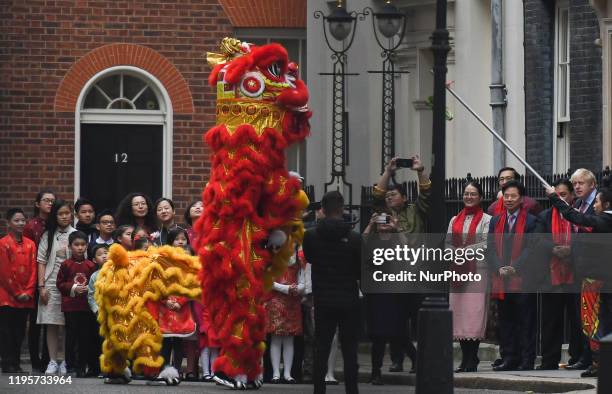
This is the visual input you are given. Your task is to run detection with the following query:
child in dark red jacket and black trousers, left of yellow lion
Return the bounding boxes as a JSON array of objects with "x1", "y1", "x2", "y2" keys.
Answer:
[{"x1": 56, "y1": 231, "x2": 98, "y2": 377}]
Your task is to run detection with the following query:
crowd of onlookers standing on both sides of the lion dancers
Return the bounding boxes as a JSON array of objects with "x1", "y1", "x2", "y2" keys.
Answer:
[{"x1": 0, "y1": 156, "x2": 612, "y2": 393}]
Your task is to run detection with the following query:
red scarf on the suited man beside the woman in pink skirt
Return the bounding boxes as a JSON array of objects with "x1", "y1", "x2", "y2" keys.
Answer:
[{"x1": 491, "y1": 207, "x2": 527, "y2": 300}]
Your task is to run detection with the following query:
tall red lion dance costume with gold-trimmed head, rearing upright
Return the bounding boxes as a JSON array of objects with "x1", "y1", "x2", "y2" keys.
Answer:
[{"x1": 195, "y1": 38, "x2": 311, "y2": 389}]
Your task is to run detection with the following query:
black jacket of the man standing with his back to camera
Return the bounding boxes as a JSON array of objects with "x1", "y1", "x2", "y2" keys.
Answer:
[{"x1": 303, "y1": 218, "x2": 361, "y2": 308}]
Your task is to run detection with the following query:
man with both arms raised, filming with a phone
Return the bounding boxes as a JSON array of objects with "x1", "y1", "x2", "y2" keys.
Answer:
[{"x1": 373, "y1": 155, "x2": 431, "y2": 372}]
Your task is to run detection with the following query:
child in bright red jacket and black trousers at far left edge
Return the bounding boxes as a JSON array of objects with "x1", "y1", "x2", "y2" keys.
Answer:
[{"x1": 0, "y1": 208, "x2": 36, "y2": 373}]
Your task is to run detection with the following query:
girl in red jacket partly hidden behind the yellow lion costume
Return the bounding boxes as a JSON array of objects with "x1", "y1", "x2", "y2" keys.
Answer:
[{"x1": 157, "y1": 227, "x2": 196, "y2": 376}]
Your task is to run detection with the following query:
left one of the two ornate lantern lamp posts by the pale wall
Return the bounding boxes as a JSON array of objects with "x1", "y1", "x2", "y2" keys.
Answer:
[{"x1": 314, "y1": 1, "x2": 363, "y2": 205}]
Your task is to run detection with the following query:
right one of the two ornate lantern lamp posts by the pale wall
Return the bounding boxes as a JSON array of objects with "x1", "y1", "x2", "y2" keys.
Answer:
[{"x1": 363, "y1": 0, "x2": 408, "y2": 174}]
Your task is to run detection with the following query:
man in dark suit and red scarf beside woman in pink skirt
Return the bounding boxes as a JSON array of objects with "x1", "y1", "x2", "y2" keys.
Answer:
[{"x1": 487, "y1": 181, "x2": 538, "y2": 371}]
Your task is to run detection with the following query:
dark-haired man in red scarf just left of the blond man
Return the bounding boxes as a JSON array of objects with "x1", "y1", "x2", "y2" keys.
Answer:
[{"x1": 537, "y1": 179, "x2": 584, "y2": 370}]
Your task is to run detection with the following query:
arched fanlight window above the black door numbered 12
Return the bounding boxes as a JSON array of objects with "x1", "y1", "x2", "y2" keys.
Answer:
[{"x1": 83, "y1": 72, "x2": 160, "y2": 111}]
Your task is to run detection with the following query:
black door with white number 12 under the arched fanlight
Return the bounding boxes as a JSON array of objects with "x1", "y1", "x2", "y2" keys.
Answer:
[{"x1": 80, "y1": 124, "x2": 163, "y2": 212}]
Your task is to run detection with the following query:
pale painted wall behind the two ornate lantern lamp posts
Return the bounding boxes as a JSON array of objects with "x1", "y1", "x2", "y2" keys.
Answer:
[{"x1": 306, "y1": 0, "x2": 525, "y2": 203}]
